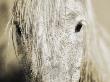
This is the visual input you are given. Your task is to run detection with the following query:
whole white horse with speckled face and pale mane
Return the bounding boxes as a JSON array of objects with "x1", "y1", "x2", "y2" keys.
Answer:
[{"x1": 0, "y1": 0, "x2": 110, "y2": 82}]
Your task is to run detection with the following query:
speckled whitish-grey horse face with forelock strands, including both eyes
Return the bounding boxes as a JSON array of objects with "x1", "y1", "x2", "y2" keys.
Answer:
[{"x1": 13, "y1": 0, "x2": 86, "y2": 82}]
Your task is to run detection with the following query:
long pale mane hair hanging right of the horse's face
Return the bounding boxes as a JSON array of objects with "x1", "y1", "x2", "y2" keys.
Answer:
[{"x1": 80, "y1": 0, "x2": 110, "y2": 82}]
